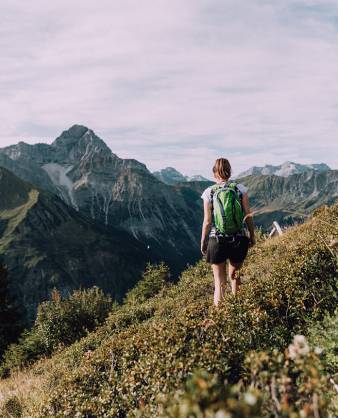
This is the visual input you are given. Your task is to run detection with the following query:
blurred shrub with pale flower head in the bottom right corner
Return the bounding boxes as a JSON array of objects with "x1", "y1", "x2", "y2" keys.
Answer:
[{"x1": 244, "y1": 335, "x2": 338, "y2": 418}]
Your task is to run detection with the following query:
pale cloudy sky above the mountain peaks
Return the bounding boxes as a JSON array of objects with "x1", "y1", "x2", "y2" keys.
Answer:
[{"x1": 0, "y1": 0, "x2": 338, "y2": 177}]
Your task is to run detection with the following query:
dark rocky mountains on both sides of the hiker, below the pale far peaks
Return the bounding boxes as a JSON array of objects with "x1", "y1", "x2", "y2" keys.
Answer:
[{"x1": 0, "y1": 125, "x2": 338, "y2": 319}]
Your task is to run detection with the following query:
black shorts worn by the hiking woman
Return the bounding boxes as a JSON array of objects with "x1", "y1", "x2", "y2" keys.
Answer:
[{"x1": 207, "y1": 235, "x2": 249, "y2": 264}]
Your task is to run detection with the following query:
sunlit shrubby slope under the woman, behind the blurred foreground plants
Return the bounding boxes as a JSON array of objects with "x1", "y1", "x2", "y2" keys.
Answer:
[{"x1": 0, "y1": 205, "x2": 338, "y2": 417}]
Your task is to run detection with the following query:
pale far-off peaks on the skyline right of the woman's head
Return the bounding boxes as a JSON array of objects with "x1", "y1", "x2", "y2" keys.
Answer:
[{"x1": 236, "y1": 161, "x2": 331, "y2": 178}]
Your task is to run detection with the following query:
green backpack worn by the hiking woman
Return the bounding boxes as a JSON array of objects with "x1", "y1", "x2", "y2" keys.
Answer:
[{"x1": 211, "y1": 183, "x2": 244, "y2": 235}]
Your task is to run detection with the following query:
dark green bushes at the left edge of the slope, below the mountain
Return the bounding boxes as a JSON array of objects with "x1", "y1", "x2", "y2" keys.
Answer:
[{"x1": 0, "y1": 287, "x2": 113, "y2": 377}]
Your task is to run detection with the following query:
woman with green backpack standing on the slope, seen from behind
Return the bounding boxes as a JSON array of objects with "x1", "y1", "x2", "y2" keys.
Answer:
[{"x1": 201, "y1": 158, "x2": 255, "y2": 306}]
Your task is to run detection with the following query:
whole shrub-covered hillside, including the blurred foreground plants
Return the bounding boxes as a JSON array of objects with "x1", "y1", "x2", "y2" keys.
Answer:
[{"x1": 0, "y1": 205, "x2": 338, "y2": 418}]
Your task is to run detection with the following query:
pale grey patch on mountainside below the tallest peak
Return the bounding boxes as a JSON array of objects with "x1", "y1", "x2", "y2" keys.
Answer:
[{"x1": 42, "y1": 163, "x2": 79, "y2": 210}]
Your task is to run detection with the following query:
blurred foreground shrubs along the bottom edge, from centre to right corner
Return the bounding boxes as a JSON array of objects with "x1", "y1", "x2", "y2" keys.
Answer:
[{"x1": 160, "y1": 335, "x2": 337, "y2": 418}]
